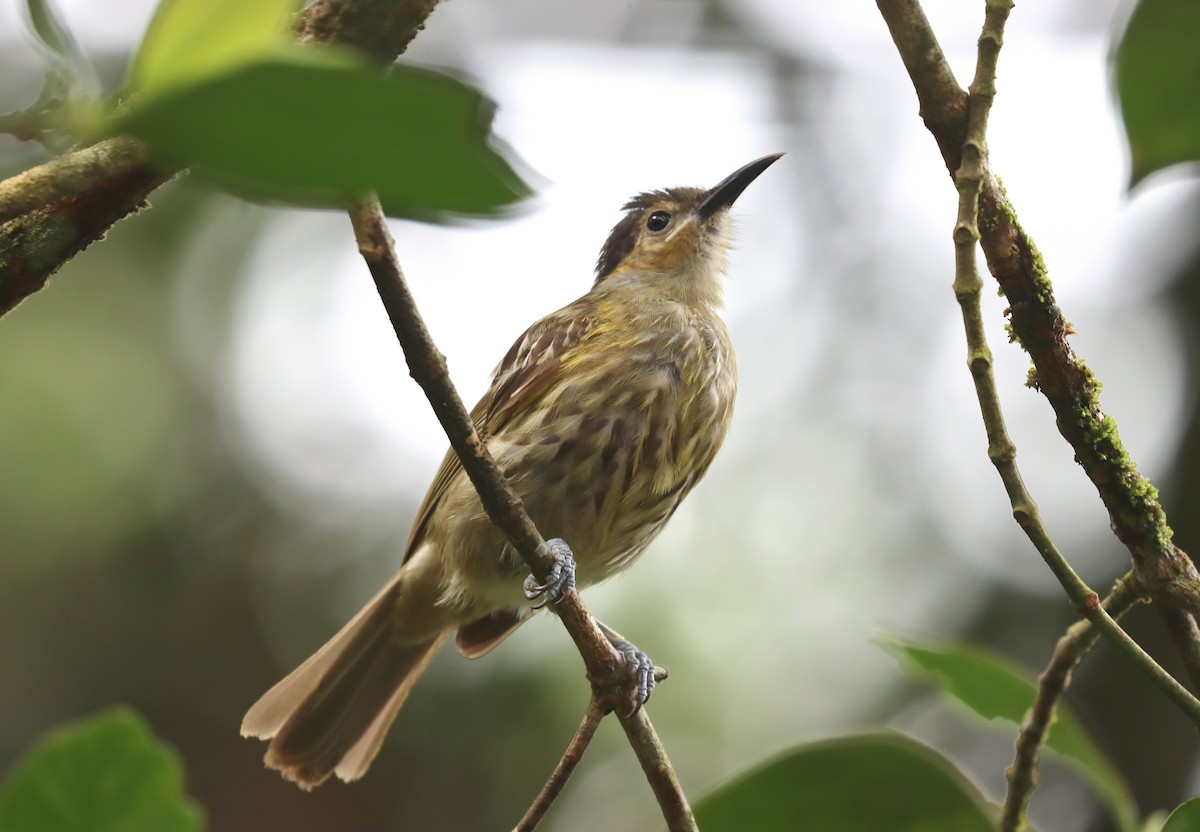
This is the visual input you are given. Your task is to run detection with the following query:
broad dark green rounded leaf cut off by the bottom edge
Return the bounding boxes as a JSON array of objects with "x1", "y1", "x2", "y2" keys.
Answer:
[{"x1": 695, "y1": 734, "x2": 994, "y2": 832}]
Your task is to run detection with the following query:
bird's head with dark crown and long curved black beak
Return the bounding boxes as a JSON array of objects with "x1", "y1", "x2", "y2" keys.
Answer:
[{"x1": 593, "y1": 154, "x2": 784, "y2": 306}]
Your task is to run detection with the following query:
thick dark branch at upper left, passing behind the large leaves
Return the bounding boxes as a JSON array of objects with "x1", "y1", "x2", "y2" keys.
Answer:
[{"x1": 0, "y1": 0, "x2": 446, "y2": 316}]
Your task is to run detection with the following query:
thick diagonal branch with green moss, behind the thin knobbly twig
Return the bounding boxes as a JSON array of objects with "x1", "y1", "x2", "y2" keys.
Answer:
[{"x1": 876, "y1": 0, "x2": 1200, "y2": 615}]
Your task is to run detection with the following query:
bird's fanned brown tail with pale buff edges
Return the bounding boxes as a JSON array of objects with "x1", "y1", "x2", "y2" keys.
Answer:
[{"x1": 241, "y1": 582, "x2": 448, "y2": 789}]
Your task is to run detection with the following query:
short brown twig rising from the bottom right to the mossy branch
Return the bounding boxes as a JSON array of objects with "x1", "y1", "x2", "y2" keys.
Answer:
[{"x1": 1000, "y1": 573, "x2": 1145, "y2": 832}]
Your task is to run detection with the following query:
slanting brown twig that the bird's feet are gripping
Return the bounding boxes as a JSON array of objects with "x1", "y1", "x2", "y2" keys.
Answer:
[{"x1": 349, "y1": 198, "x2": 696, "y2": 832}]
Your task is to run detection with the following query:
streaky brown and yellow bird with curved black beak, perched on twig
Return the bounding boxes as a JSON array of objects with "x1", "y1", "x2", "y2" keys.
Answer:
[{"x1": 241, "y1": 154, "x2": 782, "y2": 790}]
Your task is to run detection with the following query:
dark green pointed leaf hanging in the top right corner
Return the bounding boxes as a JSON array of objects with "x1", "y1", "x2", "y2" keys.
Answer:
[{"x1": 1116, "y1": 0, "x2": 1200, "y2": 184}]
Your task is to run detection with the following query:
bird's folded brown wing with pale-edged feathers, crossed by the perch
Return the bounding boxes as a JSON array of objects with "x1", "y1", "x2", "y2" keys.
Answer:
[{"x1": 404, "y1": 298, "x2": 595, "y2": 561}]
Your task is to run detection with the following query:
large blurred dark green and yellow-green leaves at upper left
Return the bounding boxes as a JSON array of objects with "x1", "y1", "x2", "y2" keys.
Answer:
[{"x1": 109, "y1": 0, "x2": 529, "y2": 221}]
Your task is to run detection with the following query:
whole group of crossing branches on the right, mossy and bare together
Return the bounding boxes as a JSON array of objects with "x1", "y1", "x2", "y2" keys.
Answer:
[{"x1": 876, "y1": 0, "x2": 1200, "y2": 832}]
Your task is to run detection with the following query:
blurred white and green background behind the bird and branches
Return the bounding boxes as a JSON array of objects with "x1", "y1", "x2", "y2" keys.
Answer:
[{"x1": 0, "y1": 0, "x2": 1200, "y2": 832}]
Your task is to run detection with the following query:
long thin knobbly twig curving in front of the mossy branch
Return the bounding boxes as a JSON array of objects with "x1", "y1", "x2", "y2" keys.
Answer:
[{"x1": 940, "y1": 0, "x2": 1200, "y2": 726}]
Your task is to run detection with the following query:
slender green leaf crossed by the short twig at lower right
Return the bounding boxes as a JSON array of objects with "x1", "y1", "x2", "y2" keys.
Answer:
[{"x1": 881, "y1": 638, "x2": 1138, "y2": 832}]
